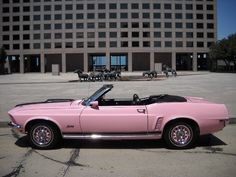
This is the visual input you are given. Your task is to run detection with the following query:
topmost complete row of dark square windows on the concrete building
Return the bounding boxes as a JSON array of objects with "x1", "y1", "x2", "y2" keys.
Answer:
[{"x1": 2, "y1": 3, "x2": 214, "y2": 13}]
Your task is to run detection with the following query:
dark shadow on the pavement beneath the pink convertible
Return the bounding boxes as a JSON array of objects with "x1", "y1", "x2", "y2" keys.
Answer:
[{"x1": 15, "y1": 134, "x2": 227, "y2": 149}]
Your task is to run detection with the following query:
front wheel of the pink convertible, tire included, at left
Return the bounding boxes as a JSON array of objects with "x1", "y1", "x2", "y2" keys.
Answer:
[{"x1": 29, "y1": 123, "x2": 60, "y2": 149}]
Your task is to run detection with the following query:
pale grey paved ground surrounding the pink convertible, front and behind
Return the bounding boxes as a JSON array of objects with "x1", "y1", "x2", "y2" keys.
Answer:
[{"x1": 0, "y1": 73, "x2": 236, "y2": 177}]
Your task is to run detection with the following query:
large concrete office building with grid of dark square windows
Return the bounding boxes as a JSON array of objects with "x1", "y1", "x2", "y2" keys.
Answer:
[{"x1": 0, "y1": 0, "x2": 217, "y2": 73}]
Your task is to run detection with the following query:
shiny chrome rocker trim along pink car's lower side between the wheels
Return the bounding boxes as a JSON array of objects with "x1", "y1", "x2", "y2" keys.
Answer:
[{"x1": 62, "y1": 132, "x2": 161, "y2": 140}]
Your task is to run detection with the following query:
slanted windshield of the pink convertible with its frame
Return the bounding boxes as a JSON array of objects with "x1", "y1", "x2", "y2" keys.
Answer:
[{"x1": 82, "y1": 85, "x2": 113, "y2": 106}]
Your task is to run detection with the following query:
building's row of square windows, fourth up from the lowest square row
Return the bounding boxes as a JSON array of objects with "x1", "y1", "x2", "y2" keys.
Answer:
[{"x1": 2, "y1": 13, "x2": 214, "y2": 22}]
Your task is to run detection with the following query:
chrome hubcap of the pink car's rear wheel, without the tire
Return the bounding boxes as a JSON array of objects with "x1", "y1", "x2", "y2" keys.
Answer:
[{"x1": 170, "y1": 125, "x2": 192, "y2": 146}]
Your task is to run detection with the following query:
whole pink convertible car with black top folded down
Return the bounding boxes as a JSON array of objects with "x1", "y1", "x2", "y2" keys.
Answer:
[{"x1": 8, "y1": 85, "x2": 229, "y2": 149}]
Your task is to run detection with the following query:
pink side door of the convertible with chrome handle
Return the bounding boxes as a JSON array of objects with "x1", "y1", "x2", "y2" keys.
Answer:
[{"x1": 80, "y1": 105, "x2": 147, "y2": 133}]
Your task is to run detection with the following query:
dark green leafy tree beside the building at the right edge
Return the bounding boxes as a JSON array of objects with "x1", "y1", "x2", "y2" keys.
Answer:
[{"x1": 209, "y1": 33, "x2": 236, "y2": 71}]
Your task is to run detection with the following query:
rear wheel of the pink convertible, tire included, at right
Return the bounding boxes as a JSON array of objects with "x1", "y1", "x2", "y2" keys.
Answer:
[{"x1": 164, "y1": 122, "x2": 198, "y2": 149}]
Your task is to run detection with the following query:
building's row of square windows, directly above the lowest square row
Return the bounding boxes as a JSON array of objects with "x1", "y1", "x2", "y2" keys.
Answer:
[{"x1": 2, "y1": 31, "x2": 214, "y2": 41}]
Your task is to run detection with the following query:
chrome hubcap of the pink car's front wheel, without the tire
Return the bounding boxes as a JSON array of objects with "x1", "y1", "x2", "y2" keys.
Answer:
[{"x1": 32, "y1": 126, "x2": 53, "y2": 146}]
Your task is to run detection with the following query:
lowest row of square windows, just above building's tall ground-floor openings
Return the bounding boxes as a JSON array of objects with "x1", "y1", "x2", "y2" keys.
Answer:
[{"x1": 3, "y1": 41, "x2": 215, "y2": 50}]
